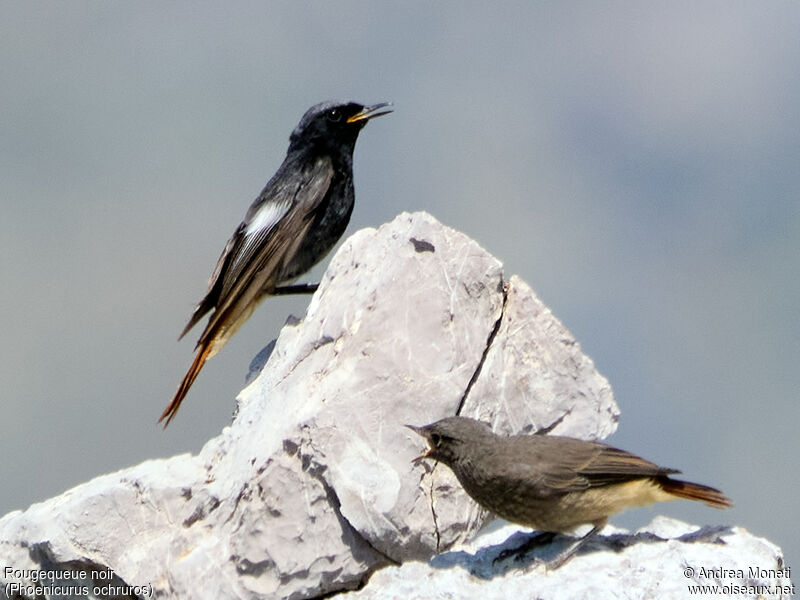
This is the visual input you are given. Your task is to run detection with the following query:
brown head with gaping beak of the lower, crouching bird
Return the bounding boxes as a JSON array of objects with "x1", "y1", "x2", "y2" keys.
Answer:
[{"x1": 406, "y1": 417, "x2": 494, "y2": 467}]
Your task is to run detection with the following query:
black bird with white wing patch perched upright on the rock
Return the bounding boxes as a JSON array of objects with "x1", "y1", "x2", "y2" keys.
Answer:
[{"x1": 159, "y1": 102, "x2": 392, "y2": 427}]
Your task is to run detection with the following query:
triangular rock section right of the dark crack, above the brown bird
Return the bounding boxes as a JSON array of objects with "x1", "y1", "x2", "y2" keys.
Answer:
[{"x1": 461, "y1": 275, "x2": 619, "y2": 439}]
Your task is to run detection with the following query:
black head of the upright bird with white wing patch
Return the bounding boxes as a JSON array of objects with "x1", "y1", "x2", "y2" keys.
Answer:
[{"x1": 289, "y1": 101, "x2": 392, "y2": 153}]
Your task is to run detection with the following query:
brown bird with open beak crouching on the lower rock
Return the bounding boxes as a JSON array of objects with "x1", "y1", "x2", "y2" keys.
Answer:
[{"x1": 407, "y1": 417, "x2": 732, "y2": 568}]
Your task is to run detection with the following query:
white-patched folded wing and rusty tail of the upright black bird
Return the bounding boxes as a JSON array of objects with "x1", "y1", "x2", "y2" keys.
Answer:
[{"x1": 159, "y1": 158, "x2": 333, "y2": 427}]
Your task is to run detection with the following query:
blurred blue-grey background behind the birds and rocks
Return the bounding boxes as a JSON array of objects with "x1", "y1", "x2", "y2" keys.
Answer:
[{"x1": 0, "y1": 1, "x2": 800, "y2": 565}]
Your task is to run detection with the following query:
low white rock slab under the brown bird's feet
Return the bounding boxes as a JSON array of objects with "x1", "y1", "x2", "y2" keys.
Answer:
[{"x1": 341, "y1": 517, "x2": 795, "y2": 600}]
